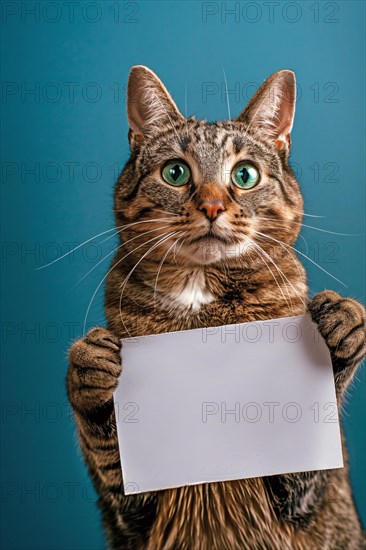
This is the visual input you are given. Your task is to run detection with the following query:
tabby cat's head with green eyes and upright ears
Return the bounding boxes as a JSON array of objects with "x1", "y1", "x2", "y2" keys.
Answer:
[{"x1": 115, "y1": 66, "x2": 303, "y2": 265}]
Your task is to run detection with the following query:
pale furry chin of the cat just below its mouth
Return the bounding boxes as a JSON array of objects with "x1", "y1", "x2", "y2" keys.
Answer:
[{"x1": 180, "y1": 238, "x2": 252, "y2": 266}]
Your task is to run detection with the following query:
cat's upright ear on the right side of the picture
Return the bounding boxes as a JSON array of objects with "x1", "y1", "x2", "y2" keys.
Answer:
[{"x1": 235, "y1": 71, "x2": 296, "y2": 149}]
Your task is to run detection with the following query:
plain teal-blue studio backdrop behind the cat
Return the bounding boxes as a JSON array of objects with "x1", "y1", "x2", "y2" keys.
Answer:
[{"x1": 1, "y1": 0, "x2": 366, "y2": 550}]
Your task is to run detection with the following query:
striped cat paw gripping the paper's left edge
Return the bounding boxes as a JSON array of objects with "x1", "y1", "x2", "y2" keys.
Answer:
[{"x1": 67, "y1": 328, "x2": 121, "y2": 410}]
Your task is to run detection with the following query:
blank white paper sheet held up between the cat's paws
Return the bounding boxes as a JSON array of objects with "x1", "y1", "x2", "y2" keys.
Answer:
[{"x1": 114, "y1": 316, "x2": 343, "y2": 494}]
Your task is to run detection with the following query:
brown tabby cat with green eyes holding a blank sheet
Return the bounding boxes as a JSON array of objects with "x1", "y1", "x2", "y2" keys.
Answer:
[{"x1": 67, "y1": 66, "x2": 365, "y2": 550}]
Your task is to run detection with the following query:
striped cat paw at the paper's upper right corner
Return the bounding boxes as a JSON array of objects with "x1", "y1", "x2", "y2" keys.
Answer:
[{"x1": 308, "y1": 290, "x2": 366, "y2": 362}]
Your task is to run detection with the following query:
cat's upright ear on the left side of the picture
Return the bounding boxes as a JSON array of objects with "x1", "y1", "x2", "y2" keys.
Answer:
[{"x1": 127, "y1": 65, "x2": 184, "y2": 141}]
